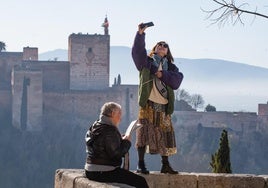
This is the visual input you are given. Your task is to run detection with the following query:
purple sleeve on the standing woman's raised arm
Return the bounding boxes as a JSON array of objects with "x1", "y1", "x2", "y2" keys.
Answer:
[{"x1": 131, "y1": 32, "x2": 148, "y2": 71}]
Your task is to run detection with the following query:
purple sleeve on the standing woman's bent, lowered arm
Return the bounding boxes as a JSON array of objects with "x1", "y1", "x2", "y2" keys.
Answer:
[{"x1": 160, "y1": 63, "x2": 184, "y2": 90}]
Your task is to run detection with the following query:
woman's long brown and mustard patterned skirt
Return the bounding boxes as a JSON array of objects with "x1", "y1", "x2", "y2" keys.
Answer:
[{"x1": 136, "y1": 101, "x2": 177, "y2": 156}]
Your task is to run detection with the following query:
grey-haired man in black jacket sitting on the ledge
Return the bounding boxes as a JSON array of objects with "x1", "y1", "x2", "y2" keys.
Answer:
[{"x1": 85, "y1": 102, "x2": 149, "y2": 188}]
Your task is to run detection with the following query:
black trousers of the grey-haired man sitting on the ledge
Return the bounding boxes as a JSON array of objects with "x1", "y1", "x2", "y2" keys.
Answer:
[{"x1": 86, "y1": 168, "x2": 149, "y2": 188}]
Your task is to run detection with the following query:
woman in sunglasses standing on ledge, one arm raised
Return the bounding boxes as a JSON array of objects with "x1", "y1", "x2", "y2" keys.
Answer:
[{"x1": 132, "y1": 24, "x2": 183, "y2": 174}]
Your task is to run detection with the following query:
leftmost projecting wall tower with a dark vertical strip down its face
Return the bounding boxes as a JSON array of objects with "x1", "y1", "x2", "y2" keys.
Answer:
[{"x1": 12, "y1": 69, "x2": 43, "y2": 131}]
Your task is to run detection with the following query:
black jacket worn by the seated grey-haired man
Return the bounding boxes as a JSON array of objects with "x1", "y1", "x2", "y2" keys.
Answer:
[{"x1": 86, "y1": 121, "x2": 131, "y2": 166}]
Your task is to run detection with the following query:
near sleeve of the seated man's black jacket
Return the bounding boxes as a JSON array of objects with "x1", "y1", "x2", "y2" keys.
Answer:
[{"x1": 105, "y1": 131, "x2": 131, "y2": 159}]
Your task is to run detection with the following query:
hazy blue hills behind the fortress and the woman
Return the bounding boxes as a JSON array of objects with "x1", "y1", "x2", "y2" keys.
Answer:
[{"x1": 39, "y1": 46, "x2": 268, "y2": 112}]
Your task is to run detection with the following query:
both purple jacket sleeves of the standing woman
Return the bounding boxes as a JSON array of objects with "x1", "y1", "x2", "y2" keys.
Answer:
[{"x1": 132, "y1": 32, "x2": 183, "y2": 90}]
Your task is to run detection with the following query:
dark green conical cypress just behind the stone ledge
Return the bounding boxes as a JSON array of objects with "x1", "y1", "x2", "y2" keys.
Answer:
[{"x1": 210, "y1": 130, "x2": 232, "y2": 173}]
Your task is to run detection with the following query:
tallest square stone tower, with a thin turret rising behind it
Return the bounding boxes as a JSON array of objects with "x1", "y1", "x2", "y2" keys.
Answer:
[{"x1": 68, "y1": 17, "x2": 110, "y2": 90}]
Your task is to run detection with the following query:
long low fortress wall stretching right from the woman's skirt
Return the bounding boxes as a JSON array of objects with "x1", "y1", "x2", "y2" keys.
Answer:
[{"x1": 174, "y1": 111, "x2": 258, "y2": 131}]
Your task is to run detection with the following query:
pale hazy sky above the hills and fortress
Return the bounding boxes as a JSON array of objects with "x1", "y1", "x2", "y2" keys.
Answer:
[{"x1": 0, "y1": 0, "x2": 268, "y2": 68}]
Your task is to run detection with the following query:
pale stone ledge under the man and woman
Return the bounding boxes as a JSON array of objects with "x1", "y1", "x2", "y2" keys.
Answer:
[{"x1": 54, "y1": 169, "x2": 268, "y2": 188}]
